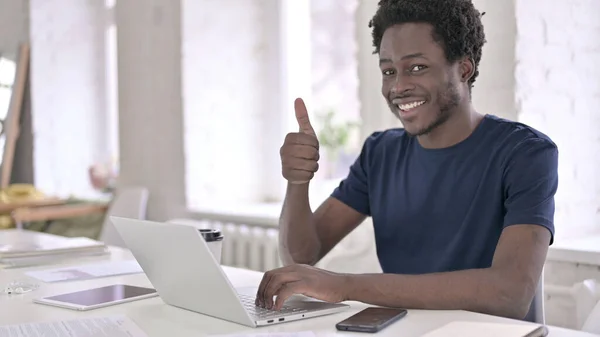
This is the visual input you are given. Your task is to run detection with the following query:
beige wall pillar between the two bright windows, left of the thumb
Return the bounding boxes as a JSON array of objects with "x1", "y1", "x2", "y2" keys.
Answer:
[{"x1": 116, "y1": 0, "x2": 185, "y2": 221}]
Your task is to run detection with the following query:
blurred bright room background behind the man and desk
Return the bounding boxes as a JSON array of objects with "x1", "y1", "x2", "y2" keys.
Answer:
[{"x1": 0, "y1": 0, "x2": 600, "y2": 326}]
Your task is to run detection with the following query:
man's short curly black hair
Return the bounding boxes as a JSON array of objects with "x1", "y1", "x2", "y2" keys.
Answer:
[{"x1": 369, "y1": 0, "x2": 486, "y2": 87}]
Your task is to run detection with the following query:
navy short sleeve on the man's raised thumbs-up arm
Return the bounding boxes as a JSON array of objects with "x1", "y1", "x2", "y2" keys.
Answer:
[{"x1": 331, "y1": 133, "x2": 379, "y2": 216}]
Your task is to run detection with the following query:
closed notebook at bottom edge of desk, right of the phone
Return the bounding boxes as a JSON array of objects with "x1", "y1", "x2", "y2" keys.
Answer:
[{"x1": 422, "y1": 321, "x2": 547, "y2": 337}]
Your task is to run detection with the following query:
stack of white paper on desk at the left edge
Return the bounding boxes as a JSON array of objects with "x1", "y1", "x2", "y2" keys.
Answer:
[{"x1": 0, "y1": 230, "x2": 107, "y2": 266}]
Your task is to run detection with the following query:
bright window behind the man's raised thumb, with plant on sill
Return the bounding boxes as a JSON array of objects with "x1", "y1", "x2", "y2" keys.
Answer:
[{"x1": 182, "y1": 0, "x2": 361, "y2": 209}]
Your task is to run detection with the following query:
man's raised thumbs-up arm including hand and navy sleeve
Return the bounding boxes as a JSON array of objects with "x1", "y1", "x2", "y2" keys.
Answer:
[{"x1": 279, "y1": 99, "x2": 369, "y2": 265}]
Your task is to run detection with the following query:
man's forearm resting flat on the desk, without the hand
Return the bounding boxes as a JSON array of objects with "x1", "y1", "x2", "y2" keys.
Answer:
[{"x1": 347, "y1": 268, "x2": 529, "y2": 319}]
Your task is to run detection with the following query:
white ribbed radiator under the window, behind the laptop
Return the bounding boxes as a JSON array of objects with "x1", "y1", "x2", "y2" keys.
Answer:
[{"x1": 169, "y1": 219, "x2": 281, "y2": 272}]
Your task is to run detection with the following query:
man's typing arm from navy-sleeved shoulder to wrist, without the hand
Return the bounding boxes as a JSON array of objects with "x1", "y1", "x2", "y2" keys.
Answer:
[{"x1": 348, "y1": 137, "x2": 558, "y2": 319}]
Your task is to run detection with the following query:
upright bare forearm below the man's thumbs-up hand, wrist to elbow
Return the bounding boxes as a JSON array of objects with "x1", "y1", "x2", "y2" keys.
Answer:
[{"x1": 279, "y1": 184, "x2": 321, "y2": 265}]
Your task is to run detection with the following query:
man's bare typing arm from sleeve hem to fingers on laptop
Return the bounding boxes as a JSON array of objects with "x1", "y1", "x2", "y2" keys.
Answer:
[{"x1": 256, "y1": 225, "x2": 551, "y2": 319}]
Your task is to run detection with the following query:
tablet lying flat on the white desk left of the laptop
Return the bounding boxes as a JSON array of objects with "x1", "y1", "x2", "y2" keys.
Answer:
[{"x1": 33, "y1": 284, "x2": 158, "y2": 310}]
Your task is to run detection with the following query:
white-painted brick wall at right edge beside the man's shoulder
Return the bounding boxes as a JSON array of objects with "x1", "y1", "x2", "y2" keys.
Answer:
[{"x1": 515, "y1": 0, "x2": 600, "y2": 238}]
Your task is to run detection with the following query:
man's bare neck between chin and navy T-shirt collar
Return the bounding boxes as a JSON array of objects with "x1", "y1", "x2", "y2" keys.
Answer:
[{"x1": 417, "y1": 103, "x2": 483, "y2": 149}]
